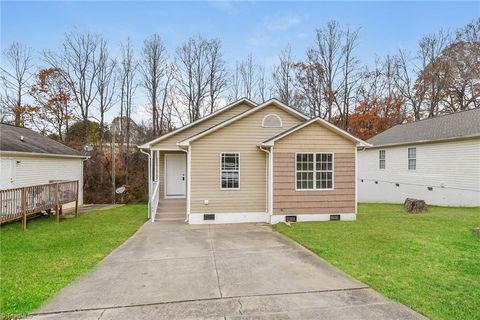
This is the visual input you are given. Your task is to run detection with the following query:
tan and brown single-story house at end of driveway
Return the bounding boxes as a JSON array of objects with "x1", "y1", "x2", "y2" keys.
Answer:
[{"x1": 140, "y1": 99, "x2": 368, "y2": 224}]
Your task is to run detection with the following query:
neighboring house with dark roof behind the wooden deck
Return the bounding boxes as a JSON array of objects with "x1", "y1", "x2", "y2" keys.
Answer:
[{"x1": 0, "y1": 124, "x2": 86, "y2": 207}]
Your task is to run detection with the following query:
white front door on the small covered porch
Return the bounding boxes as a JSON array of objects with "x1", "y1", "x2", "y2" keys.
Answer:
[{"x1": 165, "y1": 153, "x2": 187, "y2": 198}]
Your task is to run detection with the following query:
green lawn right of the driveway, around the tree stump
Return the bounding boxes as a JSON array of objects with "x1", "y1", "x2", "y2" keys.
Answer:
[{"x1": 276, "y1": 204, "x2": 480, "y2": 319}]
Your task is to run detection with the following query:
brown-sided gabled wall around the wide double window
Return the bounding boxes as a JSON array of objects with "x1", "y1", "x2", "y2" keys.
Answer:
[{"x1": 273, "y1": 123, "x2": 356, "y2": 215}]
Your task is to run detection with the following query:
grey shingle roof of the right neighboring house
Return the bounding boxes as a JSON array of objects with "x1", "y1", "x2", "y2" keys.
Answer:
[{"x1": 367, "y1": 109, "x2": 480, "y2": 147}]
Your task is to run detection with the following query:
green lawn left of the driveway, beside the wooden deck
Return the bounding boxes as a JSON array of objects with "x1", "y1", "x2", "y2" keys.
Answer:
[{"x1": 0, "y1": 204, "x2": 147, "y2": 318}]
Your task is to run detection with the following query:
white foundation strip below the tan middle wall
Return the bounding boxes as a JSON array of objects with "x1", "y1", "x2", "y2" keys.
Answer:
[{"x1": 188, "y1": 212, "x2": 270, "y2": 224}]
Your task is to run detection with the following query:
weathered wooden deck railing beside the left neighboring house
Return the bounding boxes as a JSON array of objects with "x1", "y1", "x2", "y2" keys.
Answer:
[{"x1": 0, "y1": 180, "x2": 79, "y2": 229}]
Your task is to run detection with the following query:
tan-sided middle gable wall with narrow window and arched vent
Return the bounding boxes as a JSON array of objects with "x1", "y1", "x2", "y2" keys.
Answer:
[{"x1": 190, "y1": 104, "x2": 303, "y2": 214}]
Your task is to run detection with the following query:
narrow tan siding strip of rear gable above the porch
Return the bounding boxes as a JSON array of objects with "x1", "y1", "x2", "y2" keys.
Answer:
[{"x1": 152, "y1": 104, "x2": 252, "y2": 149}]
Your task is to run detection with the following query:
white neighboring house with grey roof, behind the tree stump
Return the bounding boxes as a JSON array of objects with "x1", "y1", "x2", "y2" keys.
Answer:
[{"x1": 358, "y1": 109, "x2": 480, "y2": 206}]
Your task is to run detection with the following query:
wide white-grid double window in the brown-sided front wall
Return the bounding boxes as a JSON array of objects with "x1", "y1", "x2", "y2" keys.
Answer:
[{"x1": 295, "y1": 153, "x2": 333, "y2": 190}]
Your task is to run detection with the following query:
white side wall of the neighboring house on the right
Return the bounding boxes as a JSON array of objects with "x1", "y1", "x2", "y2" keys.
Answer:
[{"x1": 358, "y1": 138, "x2": 480, "y2": 206}]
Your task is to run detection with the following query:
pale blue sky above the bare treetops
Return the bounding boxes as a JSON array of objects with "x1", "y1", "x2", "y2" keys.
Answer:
[{"x1": 1, "y1": 1, "x2": 480, "y2": 124}]
